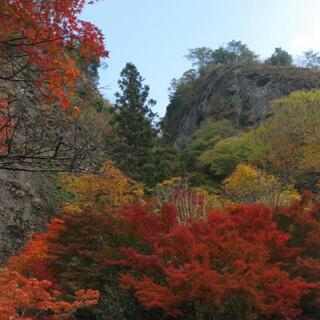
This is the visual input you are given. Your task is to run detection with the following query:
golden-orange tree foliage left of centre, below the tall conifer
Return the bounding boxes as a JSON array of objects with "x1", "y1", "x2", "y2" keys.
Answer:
[{"x1": 60, "y1": 162, "x2": 144, "y2": 211}]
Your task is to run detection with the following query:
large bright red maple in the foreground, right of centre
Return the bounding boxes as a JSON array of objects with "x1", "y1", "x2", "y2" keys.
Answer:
[{"x1": 105, "y1": 205, "x2": 313, "y2": 319}]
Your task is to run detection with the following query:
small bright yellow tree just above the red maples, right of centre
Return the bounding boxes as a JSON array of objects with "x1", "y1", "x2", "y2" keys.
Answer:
[{"x1": 222, "y1": 164, "x2": 300, "y2": 206}]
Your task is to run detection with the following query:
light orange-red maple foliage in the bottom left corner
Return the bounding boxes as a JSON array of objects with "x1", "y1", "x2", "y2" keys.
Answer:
[{"x1": 0, "y1": 269, "x2": 99, "y2": 320}]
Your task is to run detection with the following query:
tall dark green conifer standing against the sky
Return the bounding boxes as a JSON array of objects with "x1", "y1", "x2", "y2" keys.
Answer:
[{"x1": 109, "y1": 63, "x2": 157, "y2": 182}]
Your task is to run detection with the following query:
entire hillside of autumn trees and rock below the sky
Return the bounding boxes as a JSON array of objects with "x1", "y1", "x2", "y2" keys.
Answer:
[{"x1": 0, "y1": 0, "x2": 320, "y2": 320}]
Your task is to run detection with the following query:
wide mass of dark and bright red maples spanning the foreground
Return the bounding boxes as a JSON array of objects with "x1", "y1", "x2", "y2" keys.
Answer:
[{"x1": 5, "y1": 199, "x2": 320, "y2": 320}]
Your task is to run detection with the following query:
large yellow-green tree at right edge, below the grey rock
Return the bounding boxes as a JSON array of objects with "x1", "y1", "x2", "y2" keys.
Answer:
[{"x1": 257, "y1": 90, "x2": 320, "y2": 178}]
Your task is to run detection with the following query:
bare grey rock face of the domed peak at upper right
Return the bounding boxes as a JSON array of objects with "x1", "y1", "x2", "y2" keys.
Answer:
[{"x1": 164, "y1": 64, "x2": 320, "y2": 147}]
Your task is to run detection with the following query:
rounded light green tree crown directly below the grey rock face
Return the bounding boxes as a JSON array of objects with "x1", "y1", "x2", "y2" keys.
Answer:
[{"x1": 198, "y1": 132, "x2": 268, "y2": 177}]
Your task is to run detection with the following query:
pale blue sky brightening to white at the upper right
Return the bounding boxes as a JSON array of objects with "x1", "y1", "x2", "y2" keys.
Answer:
[{"x1": 81, "y1": 0, "x2": 320, "y2": 116}]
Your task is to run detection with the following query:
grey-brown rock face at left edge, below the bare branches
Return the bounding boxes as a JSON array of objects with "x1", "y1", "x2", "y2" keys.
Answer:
[{"x1": 0, "y1": 170, "x2": 58, "y2": 266}]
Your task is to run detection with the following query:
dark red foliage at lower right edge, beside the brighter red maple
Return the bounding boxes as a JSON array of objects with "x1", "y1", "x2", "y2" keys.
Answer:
[{"x1": 274, "y1": 198, "x2": 320, "y2": 319}]
